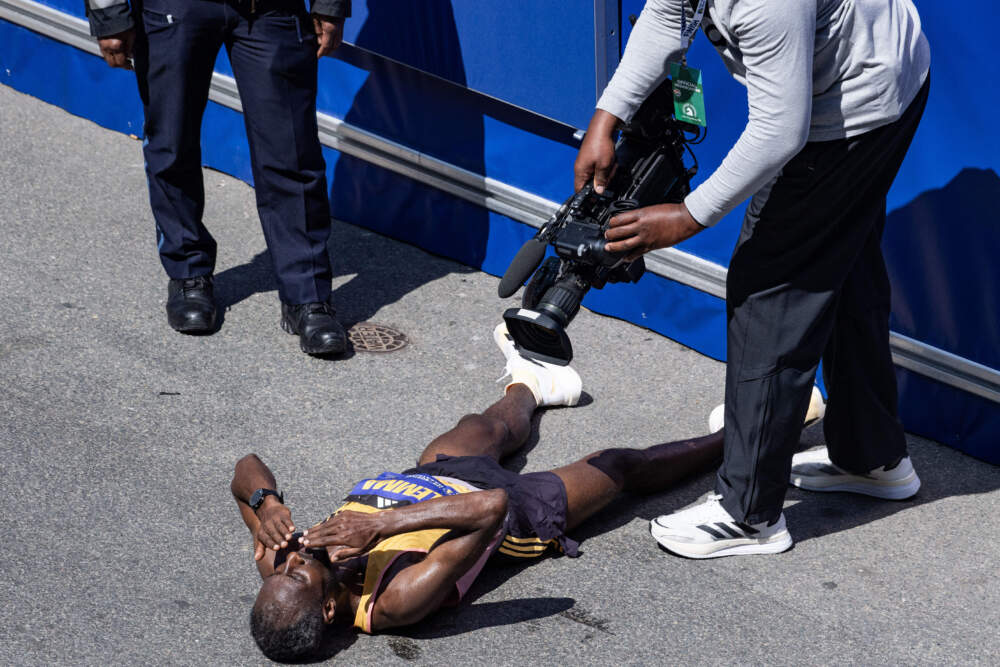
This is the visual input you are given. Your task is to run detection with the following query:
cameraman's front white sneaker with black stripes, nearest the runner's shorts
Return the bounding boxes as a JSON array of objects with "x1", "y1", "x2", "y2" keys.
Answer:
[{"x1": 649, "y1": 493, "x2": 792, "y2": 558}]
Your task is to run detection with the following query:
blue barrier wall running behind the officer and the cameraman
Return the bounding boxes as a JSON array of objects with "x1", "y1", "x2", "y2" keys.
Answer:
[{"x1": 0, "y1": 0, "x2": 1000, "y2": 462}]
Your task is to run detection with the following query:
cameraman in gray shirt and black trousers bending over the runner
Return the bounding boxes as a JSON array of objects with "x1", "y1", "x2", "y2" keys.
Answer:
[{"x1": 575, "y1": 0, "x2": 930, "y2": 558}]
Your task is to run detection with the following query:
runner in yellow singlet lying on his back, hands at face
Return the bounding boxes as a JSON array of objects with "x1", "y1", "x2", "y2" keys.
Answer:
[{"x1": 232, "y1": 324, "x2": 722, "y2": 661}]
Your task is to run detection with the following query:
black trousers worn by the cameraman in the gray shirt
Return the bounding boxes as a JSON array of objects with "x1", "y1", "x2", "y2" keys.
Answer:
[{"x1": 716, "y1": 81, "x2": 929, "y2": 523}]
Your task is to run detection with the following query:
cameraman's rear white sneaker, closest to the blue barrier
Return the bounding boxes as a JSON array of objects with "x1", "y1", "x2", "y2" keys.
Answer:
[{"x1": 790, "y1": 447, "x2": 920, "y2": 500}]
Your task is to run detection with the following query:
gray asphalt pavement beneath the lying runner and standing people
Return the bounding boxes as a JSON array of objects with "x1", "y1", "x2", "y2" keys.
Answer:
[{"x1": 0, "y1": 86, "x2": 1000, "y2": 665}]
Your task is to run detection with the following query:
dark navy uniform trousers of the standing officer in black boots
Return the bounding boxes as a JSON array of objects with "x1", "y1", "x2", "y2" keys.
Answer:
[{"x1": 135, "y1": 0, "x2": 331, "y2": 304}]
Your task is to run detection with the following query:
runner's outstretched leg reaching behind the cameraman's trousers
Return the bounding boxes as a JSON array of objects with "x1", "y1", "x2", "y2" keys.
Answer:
[{"x1": 552, "y1": 431, "x2": 722, "y2": 530}]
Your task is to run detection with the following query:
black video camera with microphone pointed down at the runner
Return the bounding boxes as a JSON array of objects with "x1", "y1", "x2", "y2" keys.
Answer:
[{"x1": 497, "y1": 79, "x2": 699, "y2": 366}]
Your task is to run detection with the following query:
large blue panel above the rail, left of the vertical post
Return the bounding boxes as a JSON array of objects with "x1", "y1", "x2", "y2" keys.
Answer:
[{"x1": 345, "y1": 0, "x2": 594, "y2": 127}]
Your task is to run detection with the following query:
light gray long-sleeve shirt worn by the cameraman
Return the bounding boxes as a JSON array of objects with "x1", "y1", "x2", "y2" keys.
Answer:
[{"x1": 597, "y1": 0, "x2": 930, "y2": 226}]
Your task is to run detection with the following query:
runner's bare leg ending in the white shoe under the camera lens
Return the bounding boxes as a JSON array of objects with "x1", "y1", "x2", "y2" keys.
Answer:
[{"x1": 418, "y1": 384, "x2": 538, "y2": 465}]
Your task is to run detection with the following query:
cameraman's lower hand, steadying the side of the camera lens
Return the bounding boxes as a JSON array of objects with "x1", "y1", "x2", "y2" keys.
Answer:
[{"x1": 604, "y1": 204, "x2": 705, "y2": 262}]
